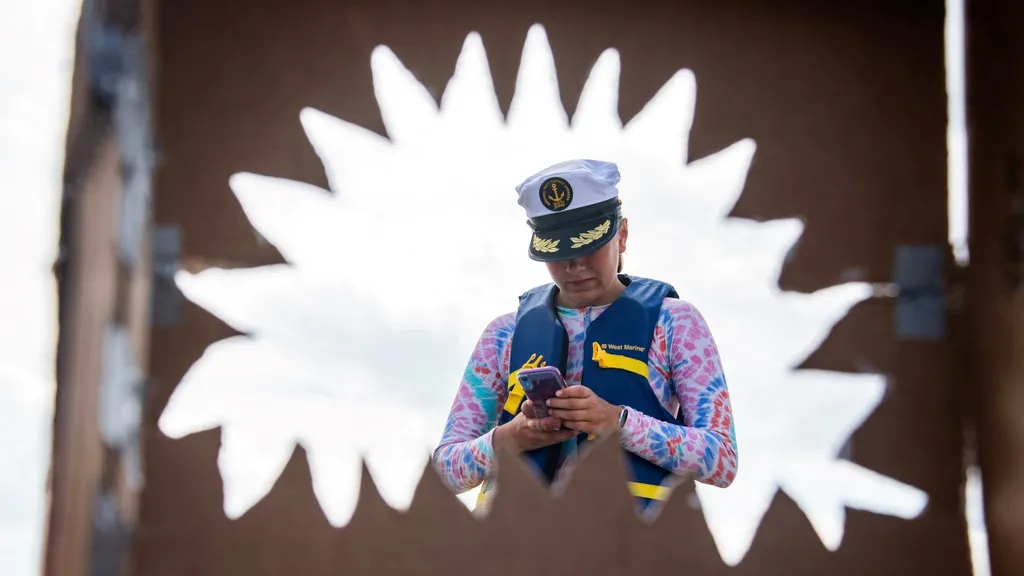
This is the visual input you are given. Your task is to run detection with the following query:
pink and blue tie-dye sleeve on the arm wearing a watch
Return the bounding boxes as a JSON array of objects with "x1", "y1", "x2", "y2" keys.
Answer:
[{"x1": 623, "y1": 299, "x2": 738, "y2": 488}]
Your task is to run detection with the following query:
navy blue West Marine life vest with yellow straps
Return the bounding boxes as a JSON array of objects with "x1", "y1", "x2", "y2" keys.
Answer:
[{"x1": 479, "y1": 275, "x2": 681, "y2": 508}]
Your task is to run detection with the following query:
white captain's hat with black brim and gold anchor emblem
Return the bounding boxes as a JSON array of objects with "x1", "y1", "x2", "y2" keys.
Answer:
[{"x1": 516, "y1": 160, "x2": 621, "y2": 262}]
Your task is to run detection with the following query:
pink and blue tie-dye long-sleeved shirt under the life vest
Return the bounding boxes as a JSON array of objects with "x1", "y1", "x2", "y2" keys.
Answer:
[{"x1": 433, "y1": 298, "x2": 737, "y2": 492}]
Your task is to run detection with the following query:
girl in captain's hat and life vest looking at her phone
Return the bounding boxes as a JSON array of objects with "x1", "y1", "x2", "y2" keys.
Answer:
[{"x1": 433, "y1": 160, "x2": 737, "y2": 509}]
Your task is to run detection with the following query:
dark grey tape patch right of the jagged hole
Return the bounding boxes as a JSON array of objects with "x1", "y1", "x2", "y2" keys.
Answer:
[{"x1": 893, "y1": 244, "x2": 948, "y2": 340}]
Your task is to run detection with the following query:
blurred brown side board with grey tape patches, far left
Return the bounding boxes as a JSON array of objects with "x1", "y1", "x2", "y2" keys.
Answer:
[{"x1": 44, "y1": 0, "x2": 152, "y2": 576}]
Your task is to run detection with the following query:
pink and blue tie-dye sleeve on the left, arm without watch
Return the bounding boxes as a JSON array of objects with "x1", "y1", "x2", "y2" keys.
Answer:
[{"x1": 433, "y1": 314, "x2": 515, "y2": 492}]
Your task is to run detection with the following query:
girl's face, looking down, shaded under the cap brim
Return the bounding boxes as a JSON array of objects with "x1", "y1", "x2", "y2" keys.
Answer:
[{"x1": 547, "y1": 218, "x2": 629, "y2": 307}]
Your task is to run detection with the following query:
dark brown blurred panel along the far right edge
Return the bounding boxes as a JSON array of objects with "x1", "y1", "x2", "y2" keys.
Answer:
[{"x1": 966, "y1": 0, "x2": 1024, "y2": 576}]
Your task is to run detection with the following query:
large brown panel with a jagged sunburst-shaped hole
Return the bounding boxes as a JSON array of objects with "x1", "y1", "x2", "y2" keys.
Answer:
[{"x1": 140, "y1": 0, "x2": 967, "y2": 576}]
